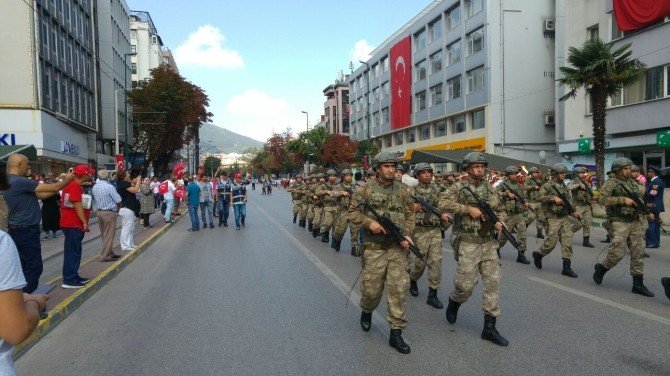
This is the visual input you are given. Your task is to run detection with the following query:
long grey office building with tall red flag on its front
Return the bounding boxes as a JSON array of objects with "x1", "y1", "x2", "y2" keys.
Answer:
[{"x1": 347, "y1": 0, "x2": 559, "y2": 163}]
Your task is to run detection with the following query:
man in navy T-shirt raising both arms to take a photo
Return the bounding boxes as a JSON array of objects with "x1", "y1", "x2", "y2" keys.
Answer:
[{"x1": 3, "y1": 154, "x2": 74, "y2": 293}]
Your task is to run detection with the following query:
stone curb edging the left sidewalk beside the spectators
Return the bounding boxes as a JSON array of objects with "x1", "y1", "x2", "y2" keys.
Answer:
[{"x1": 13, "y1": 212, "x2": 182, "y2": 361}]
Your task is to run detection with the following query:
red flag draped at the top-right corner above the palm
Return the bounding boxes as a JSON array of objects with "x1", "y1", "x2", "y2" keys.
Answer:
[{"x1": 614, "y1": 0, "x2": 670, "y2": 31}]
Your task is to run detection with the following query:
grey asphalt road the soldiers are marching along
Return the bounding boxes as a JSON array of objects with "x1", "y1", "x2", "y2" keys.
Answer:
[{"x1": 17, "y1": 189, "x2": 670, "y2": 375}]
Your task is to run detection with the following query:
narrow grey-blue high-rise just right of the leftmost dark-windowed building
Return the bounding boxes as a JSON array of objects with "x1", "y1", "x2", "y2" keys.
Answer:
[{"x1": 96, "y1": 0, "x2": 132, "y2": 164}]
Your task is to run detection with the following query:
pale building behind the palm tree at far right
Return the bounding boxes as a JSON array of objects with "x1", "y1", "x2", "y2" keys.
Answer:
[{"x1": 556, "y1": 0, "x2": 670, "y2": 171}]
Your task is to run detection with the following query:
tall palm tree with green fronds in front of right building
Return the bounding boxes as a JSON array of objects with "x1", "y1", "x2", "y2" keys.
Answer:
[{"x1": 558, "y1": 39, "x2": 646, "y2": 186}]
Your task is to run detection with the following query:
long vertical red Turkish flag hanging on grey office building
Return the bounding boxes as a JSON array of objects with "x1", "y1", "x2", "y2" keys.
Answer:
[{"x1": 391, "y1": 35, "x2": 412, "y2": 129}]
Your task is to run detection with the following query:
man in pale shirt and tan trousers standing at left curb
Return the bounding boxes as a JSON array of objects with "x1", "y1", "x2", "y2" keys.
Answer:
[{"x1": 93, "y1": 170, "x2": 121, "y2": 262}]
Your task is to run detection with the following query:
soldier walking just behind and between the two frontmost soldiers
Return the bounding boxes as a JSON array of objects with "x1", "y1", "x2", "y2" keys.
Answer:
[{"x1": 409, "y1": 162, "x2": 449, "y2": 309}]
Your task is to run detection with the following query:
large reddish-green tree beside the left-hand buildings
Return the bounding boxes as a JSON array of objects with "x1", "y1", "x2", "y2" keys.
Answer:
[{"x1": 128, "y1": 64, "x2": 212, "y2": 172}]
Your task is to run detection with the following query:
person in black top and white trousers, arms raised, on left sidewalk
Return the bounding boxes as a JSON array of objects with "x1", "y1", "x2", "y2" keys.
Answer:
[{"x1": 116, "y1": 171, "x2": 141, "y2": 252}]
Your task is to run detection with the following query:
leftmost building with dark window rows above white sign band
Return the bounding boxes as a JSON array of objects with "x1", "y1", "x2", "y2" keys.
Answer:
[{"x1": 0, "y1": 0, "x2": 99, "y2": 173}]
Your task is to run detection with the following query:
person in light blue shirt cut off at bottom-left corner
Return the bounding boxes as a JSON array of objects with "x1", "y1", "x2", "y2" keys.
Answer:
[{"x1": 0, "y1": 229, "x2": 49, "y2": 376}]
